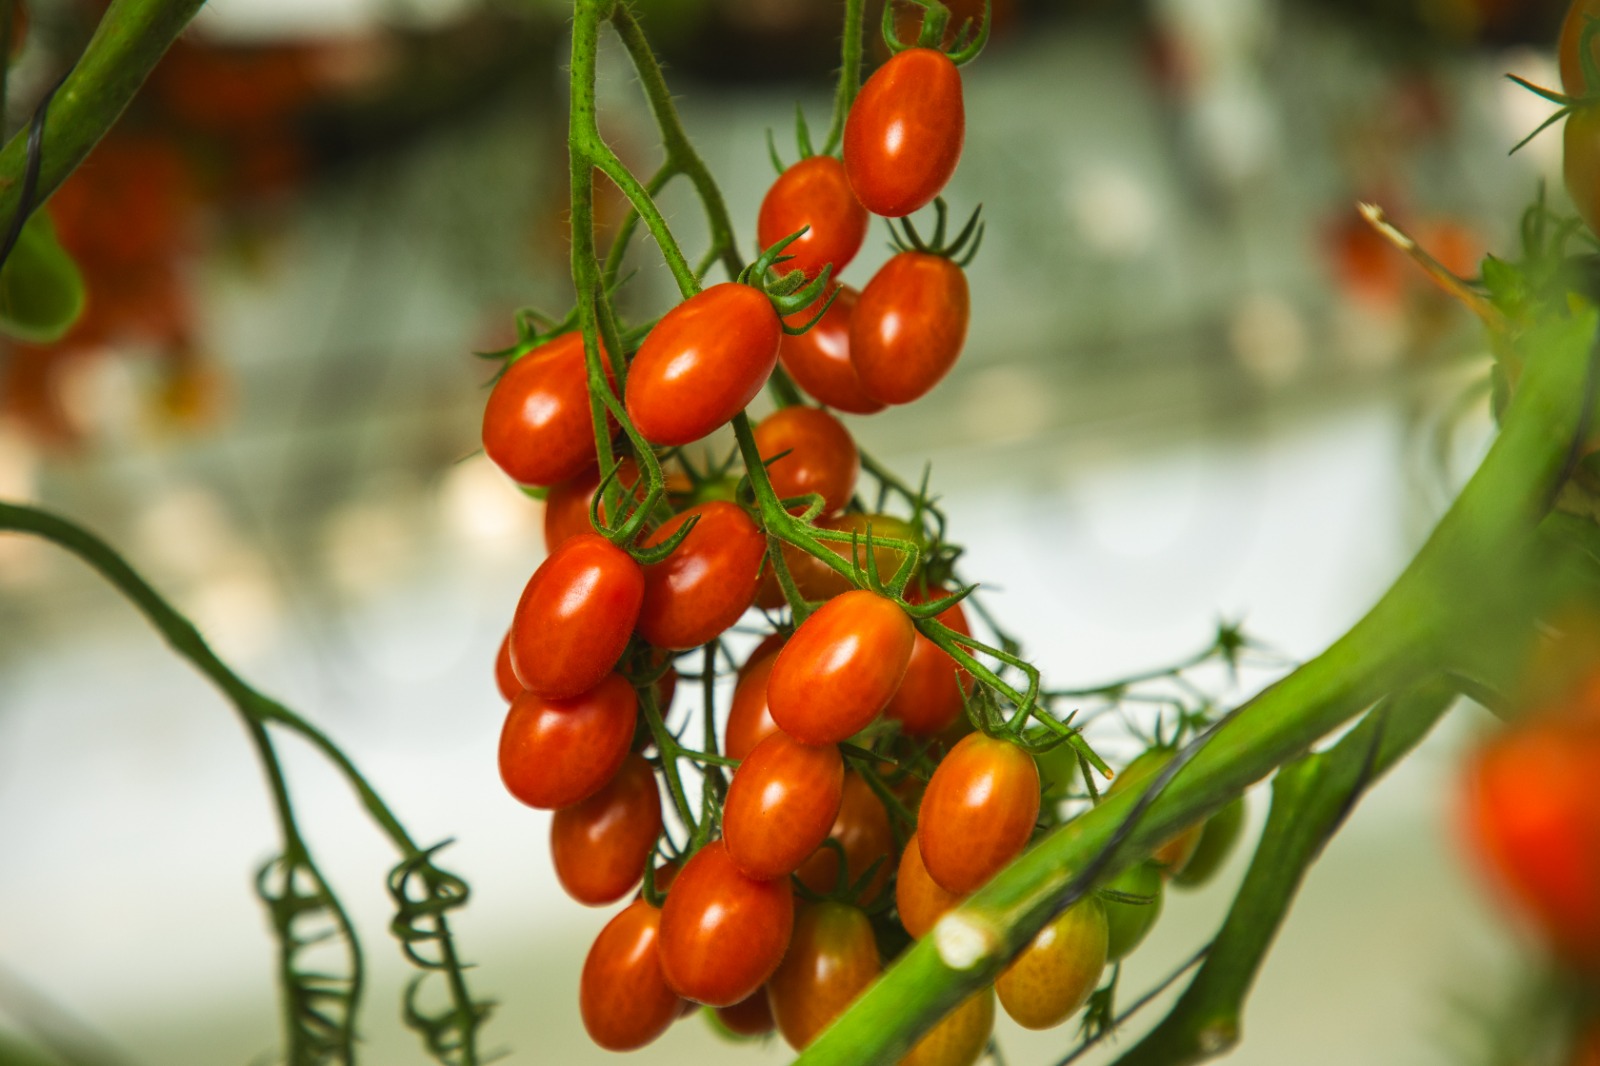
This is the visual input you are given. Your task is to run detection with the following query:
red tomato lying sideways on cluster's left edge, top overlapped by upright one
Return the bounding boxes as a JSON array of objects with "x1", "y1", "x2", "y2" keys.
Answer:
[{"x1": 499, "y1": 674, "x2": 638, "y2": 810}]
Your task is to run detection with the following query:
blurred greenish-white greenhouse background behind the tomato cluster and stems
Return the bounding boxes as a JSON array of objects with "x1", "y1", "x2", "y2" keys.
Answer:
[{"x1": 0, "y1": 0, "x2": 1565, "y2": 1066}]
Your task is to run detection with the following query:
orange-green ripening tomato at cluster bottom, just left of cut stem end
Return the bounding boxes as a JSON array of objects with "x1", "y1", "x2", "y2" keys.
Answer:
[{"x1": 766, "y1": 903, "x2": 882, "y2": 1052}]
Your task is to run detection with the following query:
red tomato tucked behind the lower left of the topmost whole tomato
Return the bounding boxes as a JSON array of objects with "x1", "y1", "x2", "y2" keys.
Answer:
[{"x1": 755, "y1": 155, "x2": 867, "y2": 279}]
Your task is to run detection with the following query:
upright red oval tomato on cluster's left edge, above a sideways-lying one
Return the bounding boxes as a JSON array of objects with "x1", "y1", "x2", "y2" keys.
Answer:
[{"x1": 510, "y1": 533, "x2": 645, "y2": 699}]
